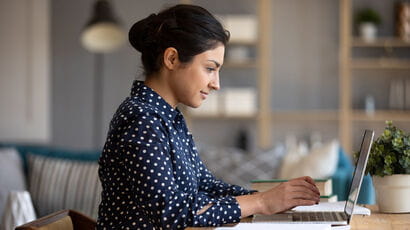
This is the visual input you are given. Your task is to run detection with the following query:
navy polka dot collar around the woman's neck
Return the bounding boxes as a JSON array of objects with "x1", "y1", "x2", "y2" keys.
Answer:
[{"x1": 131, "y1": 80, "x2": 181, "y2": 121}]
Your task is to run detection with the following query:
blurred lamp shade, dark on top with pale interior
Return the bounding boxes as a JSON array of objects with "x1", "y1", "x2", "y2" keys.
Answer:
[{"x1": 81, "y1": 0, "x2": 126, "y2": 53}]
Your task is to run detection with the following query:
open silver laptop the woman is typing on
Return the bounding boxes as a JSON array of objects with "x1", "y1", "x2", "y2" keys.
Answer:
[{"x1": 253, "y1": 130, "x2": 374, "y2": 225}]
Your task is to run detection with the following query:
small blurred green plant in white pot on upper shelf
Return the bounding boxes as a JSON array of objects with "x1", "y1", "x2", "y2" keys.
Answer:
[{"x1": 356, "y1": 8, "x2": 381, "y2": 42}]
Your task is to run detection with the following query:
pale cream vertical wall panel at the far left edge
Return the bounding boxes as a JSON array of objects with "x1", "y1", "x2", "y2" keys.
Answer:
[{"x1": 0, "y1": 0, "x2": 51, "y2": 143}]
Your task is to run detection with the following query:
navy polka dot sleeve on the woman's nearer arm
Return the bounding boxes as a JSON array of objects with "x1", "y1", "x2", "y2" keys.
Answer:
[{"x1": 120, "y1": 112, "x2": 241, "y2": 229}]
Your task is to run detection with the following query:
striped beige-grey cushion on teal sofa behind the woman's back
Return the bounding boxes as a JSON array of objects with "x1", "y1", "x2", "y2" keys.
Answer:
[{"x1": 28, "y1": 154, "x2": 101, "y2": 218}]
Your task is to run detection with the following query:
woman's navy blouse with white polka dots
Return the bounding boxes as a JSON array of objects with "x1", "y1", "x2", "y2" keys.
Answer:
[{"x1": 97, "y1": 81, "x2": 255, "y2": 229}]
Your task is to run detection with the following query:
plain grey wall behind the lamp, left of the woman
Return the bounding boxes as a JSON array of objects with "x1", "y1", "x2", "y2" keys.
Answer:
[{"x1": 51, "y1": 0, "x2": 177, "y2": 149}]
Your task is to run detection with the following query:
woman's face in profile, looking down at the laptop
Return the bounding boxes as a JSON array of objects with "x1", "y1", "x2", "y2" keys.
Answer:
[{"x1": 171, "y1": 44, "x2": 225, "y2": 108}]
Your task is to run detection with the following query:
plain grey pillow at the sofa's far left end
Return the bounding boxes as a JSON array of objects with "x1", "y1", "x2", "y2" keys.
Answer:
[{"x1": 0, "y1": 148, "x2": 26, "y2": 218}]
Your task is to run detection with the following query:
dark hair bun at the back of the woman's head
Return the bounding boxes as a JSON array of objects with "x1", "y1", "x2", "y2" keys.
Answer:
[{"x1": 128, "y1": 14, "x2": 157, "y2": 52}]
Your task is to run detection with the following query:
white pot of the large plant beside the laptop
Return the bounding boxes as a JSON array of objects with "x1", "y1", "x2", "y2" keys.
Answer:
[{"x1": 373, "y1": 174, "x2": 410, "y2": 213}]
